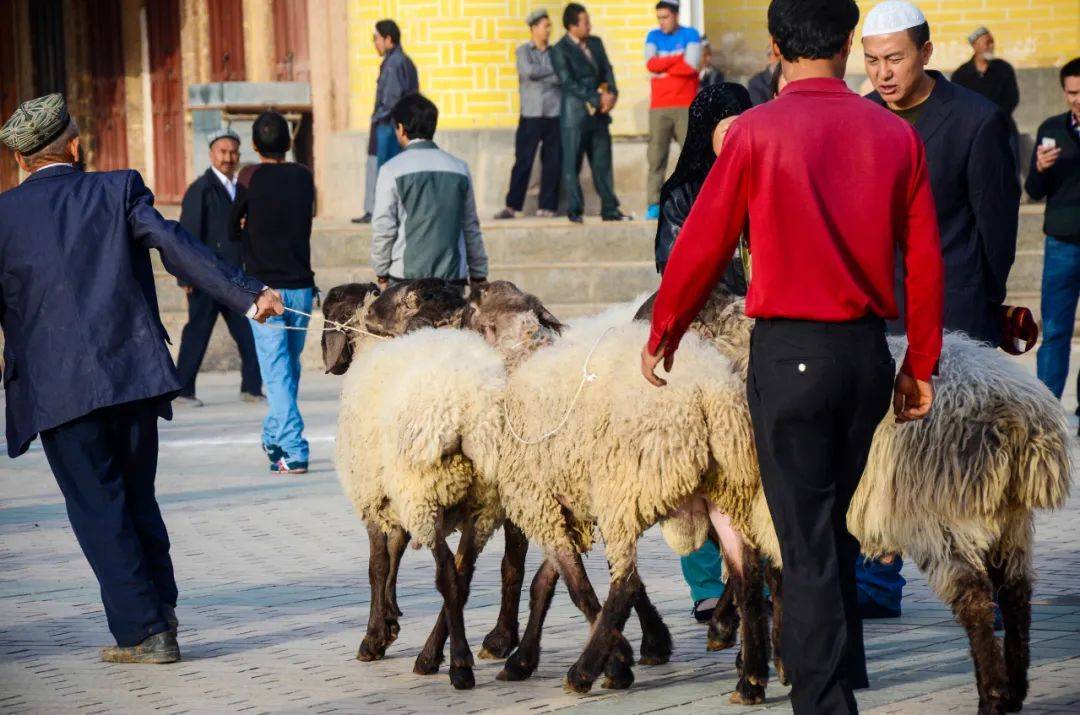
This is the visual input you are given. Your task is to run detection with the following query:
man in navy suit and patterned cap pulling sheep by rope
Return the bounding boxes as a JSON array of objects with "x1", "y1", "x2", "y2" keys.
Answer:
[{"x1": 0, "y1": 94, "x2": 283, "y2": 663}]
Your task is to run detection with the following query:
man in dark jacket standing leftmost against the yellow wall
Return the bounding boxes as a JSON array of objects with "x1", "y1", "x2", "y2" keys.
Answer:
[{"x1": 352, "y1": 19, "x2": 420, "y2": 224}]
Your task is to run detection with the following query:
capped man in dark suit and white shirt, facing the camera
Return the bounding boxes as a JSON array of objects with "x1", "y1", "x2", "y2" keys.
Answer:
[{"x1": 173, "y1": 129, "x2": 265, "y2": 407}]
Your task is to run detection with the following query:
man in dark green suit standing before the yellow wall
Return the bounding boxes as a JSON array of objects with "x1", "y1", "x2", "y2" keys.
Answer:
[{"x1": 551, "y1": 2, "x2": 631, "y2": 224}]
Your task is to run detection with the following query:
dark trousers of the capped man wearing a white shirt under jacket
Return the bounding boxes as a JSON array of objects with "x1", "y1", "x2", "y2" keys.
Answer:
[{"x1": 176, "y1": 288, "x2": 262, "y2": 397}]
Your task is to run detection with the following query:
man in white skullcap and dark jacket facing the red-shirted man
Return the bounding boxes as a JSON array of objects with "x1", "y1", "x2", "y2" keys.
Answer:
[{"x1": 856, "y1": 1, "x2": 1020, "y2": 618}]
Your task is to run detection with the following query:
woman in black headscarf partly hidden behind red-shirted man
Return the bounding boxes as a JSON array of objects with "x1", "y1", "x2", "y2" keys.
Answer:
[{"x1": 656, "y1": 82, "x2": 751, "y2": 623}]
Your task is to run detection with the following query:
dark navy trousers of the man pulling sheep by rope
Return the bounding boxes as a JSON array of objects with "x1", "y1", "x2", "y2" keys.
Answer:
[{"x1": 41, "y1": 400, "x2": 176, "y2": 646}]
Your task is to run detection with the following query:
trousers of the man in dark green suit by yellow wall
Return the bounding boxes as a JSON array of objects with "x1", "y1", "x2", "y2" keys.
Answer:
[{"x1": 562, "y1": 116, "x2": 619, "y2": 217}]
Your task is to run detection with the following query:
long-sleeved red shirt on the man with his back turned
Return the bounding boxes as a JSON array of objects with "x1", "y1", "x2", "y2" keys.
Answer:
[{"x1": 649, "y1": 79, "x2": 944, "y2": 380}]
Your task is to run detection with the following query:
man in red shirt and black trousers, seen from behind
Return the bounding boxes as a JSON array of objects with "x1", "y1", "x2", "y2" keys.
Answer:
[{"x1": 642, "y1": 0, "x2": 943, "y2": 713}]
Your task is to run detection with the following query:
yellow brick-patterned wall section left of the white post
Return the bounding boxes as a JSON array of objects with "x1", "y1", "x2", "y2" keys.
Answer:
[{"x1": 349, "y1": 0, "x2": 660, "y2": 134}]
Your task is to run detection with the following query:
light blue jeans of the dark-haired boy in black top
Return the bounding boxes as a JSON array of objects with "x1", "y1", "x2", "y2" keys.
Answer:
[{"x1": 252, "y1": 288, "x2": 314, "y2": 463}]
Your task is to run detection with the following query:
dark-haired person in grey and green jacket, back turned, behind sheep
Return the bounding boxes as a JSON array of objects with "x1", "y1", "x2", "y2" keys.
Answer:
[{"x1": 372, "y1": 94, "x2": 487, "y2": 288}]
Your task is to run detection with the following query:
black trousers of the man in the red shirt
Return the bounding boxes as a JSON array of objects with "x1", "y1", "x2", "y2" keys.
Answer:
[{"x1": 746, "y1": 318, "x2": 894, "y2": 714}]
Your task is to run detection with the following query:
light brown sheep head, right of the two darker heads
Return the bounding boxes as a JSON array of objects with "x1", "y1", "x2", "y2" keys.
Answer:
[{"x1": 469, "y1": 281, "x2": 563, "y2": 365}]
